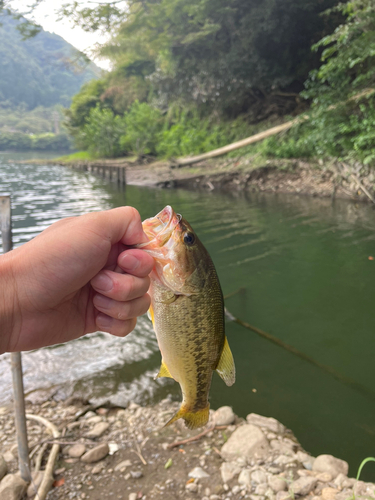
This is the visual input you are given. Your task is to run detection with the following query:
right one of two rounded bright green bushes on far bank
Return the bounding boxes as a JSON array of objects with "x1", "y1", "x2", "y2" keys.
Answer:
[{"x1": 120, "y1": 101, "x2": 163, "y2": 156}]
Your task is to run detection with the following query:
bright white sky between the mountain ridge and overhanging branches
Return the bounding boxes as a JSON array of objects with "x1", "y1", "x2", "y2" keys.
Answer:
[{"x1": 11, "y1": 0, "x2": 110, "y2": 69}]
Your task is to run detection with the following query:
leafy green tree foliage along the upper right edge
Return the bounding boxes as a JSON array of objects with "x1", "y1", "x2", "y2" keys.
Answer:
[{"x1": 288, "y1": 0, "x2": 375, "y2": 165}]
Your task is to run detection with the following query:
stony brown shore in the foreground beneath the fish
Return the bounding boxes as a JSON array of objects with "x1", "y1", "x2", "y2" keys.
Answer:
[{"x1": 0, "y1": 399, "x2": 375, "y2": 500}]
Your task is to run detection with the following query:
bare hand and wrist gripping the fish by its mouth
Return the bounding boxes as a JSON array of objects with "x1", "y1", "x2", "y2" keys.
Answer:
[{"x1": 0, "y1": 207, "x2": 154, "y2": 353}]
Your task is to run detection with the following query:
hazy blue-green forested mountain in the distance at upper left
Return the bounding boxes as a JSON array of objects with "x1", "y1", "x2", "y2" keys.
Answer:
[{"x1": 0, "y1": 14, "x2": 101, "y2": 110}]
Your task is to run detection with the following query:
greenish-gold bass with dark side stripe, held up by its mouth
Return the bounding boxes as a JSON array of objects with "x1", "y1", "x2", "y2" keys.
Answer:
[{"x1": 137, "y1": 205, "x2": 235, "y2": 429}]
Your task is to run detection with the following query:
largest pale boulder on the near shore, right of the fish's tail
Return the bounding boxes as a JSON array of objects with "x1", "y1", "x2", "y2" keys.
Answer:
[{"x1": 221, "y1": 425, "x2": 270, "y2": 461}]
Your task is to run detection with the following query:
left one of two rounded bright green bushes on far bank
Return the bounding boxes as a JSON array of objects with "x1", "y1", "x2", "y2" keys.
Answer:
[{"x1": 76, "y1": 106, "x2": 126, "y2": 158}]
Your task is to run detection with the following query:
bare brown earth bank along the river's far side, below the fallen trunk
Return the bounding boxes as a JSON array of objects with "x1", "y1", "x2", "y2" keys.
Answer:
[{"x1": 51, "y1": 155, "x2": 375, "y2": 202}]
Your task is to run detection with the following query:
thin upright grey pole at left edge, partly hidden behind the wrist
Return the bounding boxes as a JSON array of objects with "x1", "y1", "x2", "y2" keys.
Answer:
[{"x1": 0, "y1": 195, "x2": 31, "y2": 482}]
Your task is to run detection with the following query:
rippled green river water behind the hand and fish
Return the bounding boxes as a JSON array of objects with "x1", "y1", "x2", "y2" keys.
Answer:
[{"x1": 0, "y1": 154, "x2": 375, "y2": 475}]
